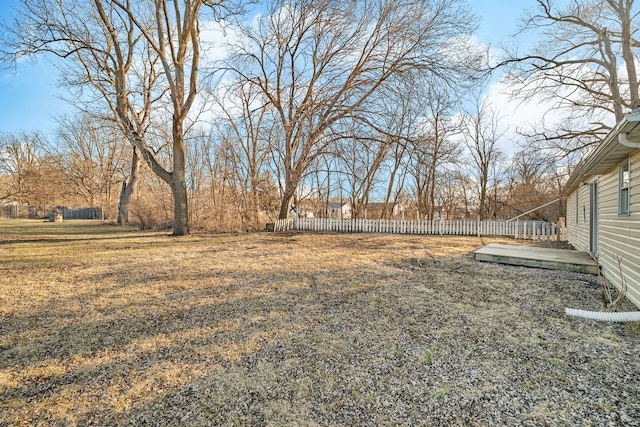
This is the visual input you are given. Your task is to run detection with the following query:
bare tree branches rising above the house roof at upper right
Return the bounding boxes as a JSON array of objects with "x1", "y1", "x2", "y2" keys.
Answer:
[{"x1": 501, "y1": 0, "x2": 640, "y2": 155}]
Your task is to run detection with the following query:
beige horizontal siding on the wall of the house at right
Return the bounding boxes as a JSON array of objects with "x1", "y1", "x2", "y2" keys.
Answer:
[{"x1": 587, "y1": 151, "x2": 640, "y2": 307}]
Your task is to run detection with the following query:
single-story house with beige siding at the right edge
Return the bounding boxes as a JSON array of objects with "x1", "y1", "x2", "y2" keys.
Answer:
[{"x1": 563, "y1": 109, "x2": 640, "y2": 307}]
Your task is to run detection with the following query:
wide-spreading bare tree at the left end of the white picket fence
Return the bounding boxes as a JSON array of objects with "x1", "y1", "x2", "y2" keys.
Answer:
[{"x1": 230, "y1": 0, "x2": 482, "y2": 218}]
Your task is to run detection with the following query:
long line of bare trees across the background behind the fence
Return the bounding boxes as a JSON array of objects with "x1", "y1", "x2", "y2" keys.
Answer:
[{"x1": 0, "y1": 0, "x2": 637, "y2": 235}]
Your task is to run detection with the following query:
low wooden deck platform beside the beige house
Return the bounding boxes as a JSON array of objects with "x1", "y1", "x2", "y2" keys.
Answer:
[{"x1": 474, "y1": 243, "x2": 598, "y2": 274}]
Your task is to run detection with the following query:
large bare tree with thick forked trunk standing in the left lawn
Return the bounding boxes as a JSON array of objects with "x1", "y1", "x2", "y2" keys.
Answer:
[{"x1": 3, "y1": 0, "x2": 232, "y2": 235}]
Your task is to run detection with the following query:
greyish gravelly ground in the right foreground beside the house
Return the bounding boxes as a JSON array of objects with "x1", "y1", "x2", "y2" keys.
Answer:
[{"x1": 130, "y1": 236, "x2": 640, "y2": 426}]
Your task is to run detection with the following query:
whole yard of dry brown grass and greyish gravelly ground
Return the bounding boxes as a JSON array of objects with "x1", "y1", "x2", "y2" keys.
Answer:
[{"x1": 0, "y1": 221, "x2": 640, "y2": 426}]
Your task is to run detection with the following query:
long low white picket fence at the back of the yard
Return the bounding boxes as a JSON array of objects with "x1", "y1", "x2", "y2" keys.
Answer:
[{"x1": 274, "y1": 218, "x2": 567, "y2": 241}]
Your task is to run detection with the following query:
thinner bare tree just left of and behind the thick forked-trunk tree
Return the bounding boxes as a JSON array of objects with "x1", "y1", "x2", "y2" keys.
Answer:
[{"x1": 3, "y1": 0, "x2": 161, "y2": 227}]
